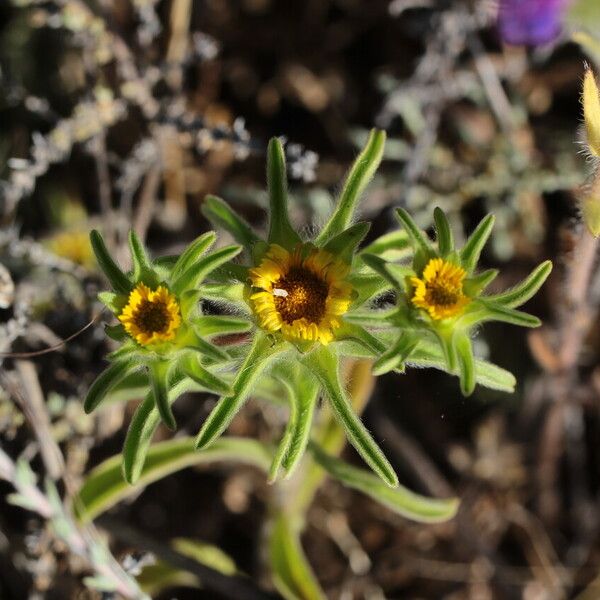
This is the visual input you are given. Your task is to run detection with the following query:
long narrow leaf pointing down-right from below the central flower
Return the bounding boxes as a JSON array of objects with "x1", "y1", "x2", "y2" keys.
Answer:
[{"x1": 305, "y1": 348, "x2": 398, "y2": 487}]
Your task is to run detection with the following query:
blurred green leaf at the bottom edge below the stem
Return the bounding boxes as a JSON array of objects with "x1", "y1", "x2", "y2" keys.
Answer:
[{"x1": 269, "y1": 513, "x2": 326, "y2": 600}]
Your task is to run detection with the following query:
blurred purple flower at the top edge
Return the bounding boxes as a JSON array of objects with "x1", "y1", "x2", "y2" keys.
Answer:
[{"x1": 498, "y1": 0, "x2": 569, "y2": 46}]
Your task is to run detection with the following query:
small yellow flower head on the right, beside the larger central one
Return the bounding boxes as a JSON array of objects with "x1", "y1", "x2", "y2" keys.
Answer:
[{"x1": 410, "y1": 258, "x2": 471, "y2": 321}]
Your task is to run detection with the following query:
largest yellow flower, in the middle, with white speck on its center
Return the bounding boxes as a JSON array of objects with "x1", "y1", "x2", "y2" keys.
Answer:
[{"x1": 250, "y1": 244, "x2": 352, "y2": 344}]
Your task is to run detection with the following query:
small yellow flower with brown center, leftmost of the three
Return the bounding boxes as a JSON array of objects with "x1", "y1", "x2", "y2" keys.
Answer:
[{"x1": 119, "y1": 283, "x2": 181, "y2": 345}]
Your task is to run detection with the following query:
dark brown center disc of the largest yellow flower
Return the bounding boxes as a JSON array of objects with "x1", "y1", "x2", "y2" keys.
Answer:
[{"x1": 273, "y1": 267, "x2": 329, "y2": 324}]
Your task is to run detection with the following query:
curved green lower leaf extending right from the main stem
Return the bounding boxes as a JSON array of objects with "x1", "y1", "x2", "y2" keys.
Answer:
[{"x1": 309, "y1": 443, "x2": 459, "y2": 523}]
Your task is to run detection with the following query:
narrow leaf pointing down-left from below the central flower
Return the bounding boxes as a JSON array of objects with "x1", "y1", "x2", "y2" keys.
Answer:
[{"x1": 196, "y1": 334, "x2": 282, "y2": 448}]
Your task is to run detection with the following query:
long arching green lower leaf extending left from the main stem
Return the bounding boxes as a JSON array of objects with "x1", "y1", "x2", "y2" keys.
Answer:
[{"x1": 74, "y1": 437, "x2": 271, "y2": 523}]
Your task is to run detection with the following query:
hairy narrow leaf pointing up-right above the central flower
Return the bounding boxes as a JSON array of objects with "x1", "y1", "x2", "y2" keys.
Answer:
[{"x1": 316, "y1": 129, "x2": 385, "y2": 245}]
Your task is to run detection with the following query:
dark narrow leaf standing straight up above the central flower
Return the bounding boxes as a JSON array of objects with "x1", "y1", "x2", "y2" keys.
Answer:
[{"x1": 267, "y1": 138, "x2": 301, "y2": 248}]
